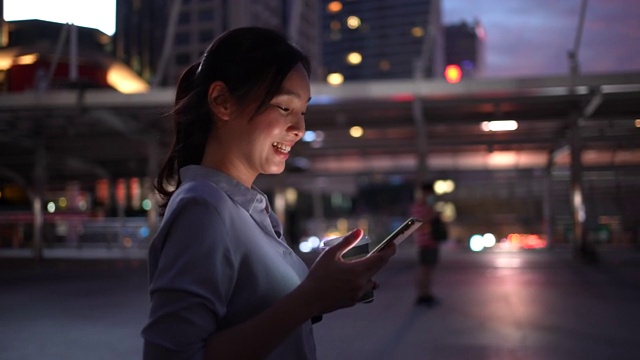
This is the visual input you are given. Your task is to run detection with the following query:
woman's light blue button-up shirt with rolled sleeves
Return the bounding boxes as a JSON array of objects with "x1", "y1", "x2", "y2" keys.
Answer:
[{"x1": 142, "y1": 165, "x2": 316, "y2": 360}]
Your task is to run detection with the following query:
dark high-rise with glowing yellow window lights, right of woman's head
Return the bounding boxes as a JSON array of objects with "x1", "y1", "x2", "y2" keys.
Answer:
[{"x1": 322, "y1": 0, "x2": 444, "y2": 81}]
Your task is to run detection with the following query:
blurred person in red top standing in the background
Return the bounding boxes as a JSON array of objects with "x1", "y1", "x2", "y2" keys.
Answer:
[{"x1": 411, "y1": 182, "x2": 447, "y2": 307}]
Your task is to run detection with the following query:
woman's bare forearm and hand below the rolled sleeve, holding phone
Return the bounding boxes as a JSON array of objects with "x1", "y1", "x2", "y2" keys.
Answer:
[{"x1": 205, "y1": 229, "x2": 395, "y2": 360}]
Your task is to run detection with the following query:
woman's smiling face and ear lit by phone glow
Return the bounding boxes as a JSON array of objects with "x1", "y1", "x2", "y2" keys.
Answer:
[{"x1": 203, "y1": 65, "x2": 310, "y2": 186}]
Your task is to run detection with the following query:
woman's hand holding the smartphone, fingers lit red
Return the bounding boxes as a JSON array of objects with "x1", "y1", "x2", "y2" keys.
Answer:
[{"x1": 300, "y1": 229, "x2": 396, "y2": 314}]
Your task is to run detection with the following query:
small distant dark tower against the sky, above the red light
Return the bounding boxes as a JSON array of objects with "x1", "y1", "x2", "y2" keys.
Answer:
[{"x1": 445, "y1": 20, "x2": 485, "y2": 77}]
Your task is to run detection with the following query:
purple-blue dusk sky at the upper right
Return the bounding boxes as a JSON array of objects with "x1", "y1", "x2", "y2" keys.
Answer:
[{"x1": 442, "y1": 0, "x2": 640, "y2": 77}]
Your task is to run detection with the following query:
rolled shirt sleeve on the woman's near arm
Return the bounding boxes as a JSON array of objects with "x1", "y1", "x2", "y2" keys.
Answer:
[{"x1": 142, "y1": 197, "x2": 237, "y2": 359}]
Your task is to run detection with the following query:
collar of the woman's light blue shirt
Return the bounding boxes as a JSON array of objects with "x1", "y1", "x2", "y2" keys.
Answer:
[{"x1": 180, "y1": 165, "x2": 271, "y2": 213}]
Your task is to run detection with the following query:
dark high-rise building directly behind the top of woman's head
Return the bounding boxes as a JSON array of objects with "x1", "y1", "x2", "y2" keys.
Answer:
[{"x1": 115, "y1": 0, "x2": 321, "y2": 85}]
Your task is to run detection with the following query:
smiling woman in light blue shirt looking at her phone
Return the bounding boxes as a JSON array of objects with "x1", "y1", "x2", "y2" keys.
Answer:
[{"x1": 142, "y1": 27, "x2": 395, "y2": 359}]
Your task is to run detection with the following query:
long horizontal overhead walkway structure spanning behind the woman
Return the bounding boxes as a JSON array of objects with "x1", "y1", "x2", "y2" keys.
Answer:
[{"x1": 0, "y1": 73, "x2": 640, "y2": 256}]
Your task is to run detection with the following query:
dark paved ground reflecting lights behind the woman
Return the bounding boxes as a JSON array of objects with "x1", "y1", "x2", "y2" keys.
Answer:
[{"x1": 0, "y1": 244, "x2": 640, "y2": 360}]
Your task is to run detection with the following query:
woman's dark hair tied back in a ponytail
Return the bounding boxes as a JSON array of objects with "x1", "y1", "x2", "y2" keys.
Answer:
[{"x1": 154, "y1": 27, "x2": 311, "y2": 214}]
